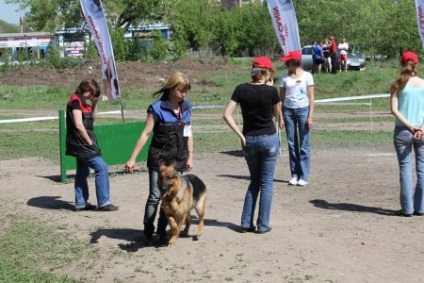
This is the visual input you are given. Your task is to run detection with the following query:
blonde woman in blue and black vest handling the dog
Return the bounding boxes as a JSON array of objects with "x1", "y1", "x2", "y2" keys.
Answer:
[{"x1": 125, "y1": 72, "x2": 193, "y2": 242}]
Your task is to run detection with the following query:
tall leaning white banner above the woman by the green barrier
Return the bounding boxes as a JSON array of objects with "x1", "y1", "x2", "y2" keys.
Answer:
[{"x1": 80, "y1": 0, "x2": 120, "y2": 100}]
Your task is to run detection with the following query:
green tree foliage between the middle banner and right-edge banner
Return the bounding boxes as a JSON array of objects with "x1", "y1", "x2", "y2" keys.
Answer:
[{"x1": 294, "y1": 0, "x2": 421, "y2": 56}]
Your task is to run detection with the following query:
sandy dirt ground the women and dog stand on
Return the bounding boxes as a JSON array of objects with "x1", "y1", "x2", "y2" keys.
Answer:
[{"x1": 0, "y1": 146, "x2": 424, "y2": 282}]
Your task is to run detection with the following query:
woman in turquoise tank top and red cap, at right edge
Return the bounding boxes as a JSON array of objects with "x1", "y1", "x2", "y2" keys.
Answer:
[{"x1": 390, "y1": 51, "x2": 424, "y2": 217}]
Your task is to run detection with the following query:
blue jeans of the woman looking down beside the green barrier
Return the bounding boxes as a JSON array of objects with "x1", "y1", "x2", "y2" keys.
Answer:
[{"x1": 74, "y1": 156, "x2": 110, "y2": 209}]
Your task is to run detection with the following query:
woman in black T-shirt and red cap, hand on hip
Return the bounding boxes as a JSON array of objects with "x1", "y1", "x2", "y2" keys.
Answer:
[{"x1": 223, "y1": 57, "x2": 280, "y2": 234}]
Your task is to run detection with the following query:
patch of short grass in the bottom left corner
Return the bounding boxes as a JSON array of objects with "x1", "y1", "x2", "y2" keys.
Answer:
[{"x1": 0, "y1": 214, "x2": 98, "y2": 283}]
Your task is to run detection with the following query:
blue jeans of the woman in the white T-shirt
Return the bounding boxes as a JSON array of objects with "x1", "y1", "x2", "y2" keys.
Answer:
[{"x1": 283, "y1": 107, "x2": 311, "y2": 182}]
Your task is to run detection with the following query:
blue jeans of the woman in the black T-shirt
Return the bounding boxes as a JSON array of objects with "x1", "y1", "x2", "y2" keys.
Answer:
[{"x1": 241, "y1": 134, "x2": 278, "y2": 231}]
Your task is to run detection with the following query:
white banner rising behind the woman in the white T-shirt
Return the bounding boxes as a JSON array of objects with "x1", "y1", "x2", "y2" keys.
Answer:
[{"x1": 268, "y1": 0, "x2": 301, "y2": 54}]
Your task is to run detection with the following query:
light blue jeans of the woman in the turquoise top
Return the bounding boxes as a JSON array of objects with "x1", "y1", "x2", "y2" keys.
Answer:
[{"x1": 393, "y1": 126, "x2": 424, "y2": 214}]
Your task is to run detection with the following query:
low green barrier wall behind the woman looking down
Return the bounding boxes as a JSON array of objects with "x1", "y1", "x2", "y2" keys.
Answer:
[{"x1": 59, "y1": 110, "x2": 152, "y2": 183}]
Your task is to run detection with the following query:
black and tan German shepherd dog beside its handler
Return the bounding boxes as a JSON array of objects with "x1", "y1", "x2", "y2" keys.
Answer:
[{"x1": 158, "y1": 165, "x2": 206, "y2": 246}]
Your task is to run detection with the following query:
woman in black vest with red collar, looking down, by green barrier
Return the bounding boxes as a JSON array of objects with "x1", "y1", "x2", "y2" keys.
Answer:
[{"x1": 66, "y1": 79, "x2": 119, "y2": 211}]
